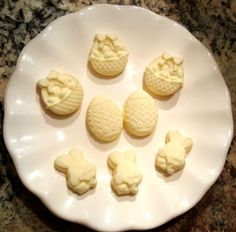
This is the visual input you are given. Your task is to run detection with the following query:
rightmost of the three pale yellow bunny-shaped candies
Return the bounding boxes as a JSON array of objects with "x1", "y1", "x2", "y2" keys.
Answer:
[{"x1": 156, "y1": 130, "x2": 193, "y2": 175}]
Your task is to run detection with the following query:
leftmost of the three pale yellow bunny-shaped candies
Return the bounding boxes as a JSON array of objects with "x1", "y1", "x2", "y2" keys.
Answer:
[{"x1": 54, "y1": 149, "x2": 97, "y2": 195}]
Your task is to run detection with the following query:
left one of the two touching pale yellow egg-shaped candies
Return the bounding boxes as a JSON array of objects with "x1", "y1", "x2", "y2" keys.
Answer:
[{"x1": 86, "y1": 96, "x2": 123, "y2": 142}]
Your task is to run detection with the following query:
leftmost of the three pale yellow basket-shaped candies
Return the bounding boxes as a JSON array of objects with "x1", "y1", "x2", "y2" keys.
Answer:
[{"x1": 37, "y1": 71, "x2": 83, "y2": 115}]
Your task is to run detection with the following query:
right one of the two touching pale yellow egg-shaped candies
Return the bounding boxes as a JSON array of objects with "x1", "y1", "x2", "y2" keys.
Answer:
[{"x1": 123, "y1": 90, "x2": 158, "y2": 137}]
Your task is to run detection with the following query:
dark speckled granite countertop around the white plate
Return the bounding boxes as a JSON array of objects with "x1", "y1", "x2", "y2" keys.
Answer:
[{"x1": 0, "y1": 0, "x2": 236, "y2": 232}]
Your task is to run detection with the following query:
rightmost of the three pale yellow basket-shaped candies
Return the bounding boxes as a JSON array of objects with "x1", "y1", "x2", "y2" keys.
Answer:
[{"x1": 144, "y1": 53, "x2": 184, "y2": 96}]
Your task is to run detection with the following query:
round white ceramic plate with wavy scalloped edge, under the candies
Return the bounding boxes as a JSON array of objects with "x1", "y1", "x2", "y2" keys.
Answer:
[{"x1": 4, "y1": 5, "x2": 233, "y2": 231}]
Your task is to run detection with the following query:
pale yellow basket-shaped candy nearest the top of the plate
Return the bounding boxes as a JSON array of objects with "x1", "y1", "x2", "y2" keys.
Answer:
[{"x1": 89, "y1": 34, "x2": 128, "y2": 76}]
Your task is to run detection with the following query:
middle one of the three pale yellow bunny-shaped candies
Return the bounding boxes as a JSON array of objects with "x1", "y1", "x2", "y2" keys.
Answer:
[{"x1": 107, "y1": 151, "x2": 142, "y2": 195}]
